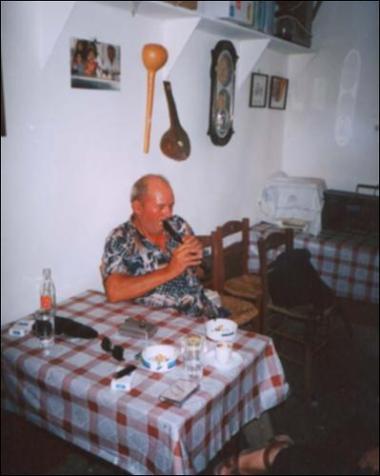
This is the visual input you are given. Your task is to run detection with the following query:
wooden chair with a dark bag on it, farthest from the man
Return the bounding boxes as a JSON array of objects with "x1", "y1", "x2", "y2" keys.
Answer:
[{"x1": 258, "y1": 229, "x2": 347, "y2": 401}]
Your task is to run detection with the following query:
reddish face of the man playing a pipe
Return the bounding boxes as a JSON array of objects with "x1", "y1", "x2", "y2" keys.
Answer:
[{"x1": 132, "y1": 180, "x2": 174, "y2": 235}]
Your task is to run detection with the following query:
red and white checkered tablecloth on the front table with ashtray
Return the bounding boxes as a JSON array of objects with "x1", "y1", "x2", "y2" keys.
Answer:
[{"x1": 2, "y1": 291, "x2": 288, "y2": 474}]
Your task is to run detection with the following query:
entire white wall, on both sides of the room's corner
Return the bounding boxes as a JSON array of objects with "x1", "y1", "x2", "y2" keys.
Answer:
[{"x1": 1, "y1": 1, "x2": 378, "y2": 323}]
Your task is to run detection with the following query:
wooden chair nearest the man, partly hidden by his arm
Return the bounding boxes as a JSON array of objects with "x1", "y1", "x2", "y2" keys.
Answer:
[{"x1": 197, "y1": 233, "x2": 258, "y2": 327}]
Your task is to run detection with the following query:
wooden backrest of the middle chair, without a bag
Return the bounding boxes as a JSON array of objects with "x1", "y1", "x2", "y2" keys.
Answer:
[{"x1": 212, "y1": 218, "x2": 249, "y2": 292}]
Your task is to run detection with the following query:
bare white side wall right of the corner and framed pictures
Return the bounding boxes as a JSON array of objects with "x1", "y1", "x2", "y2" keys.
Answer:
[{"x1": 283, "y1": 1, "x2": 379, "y2": 190}]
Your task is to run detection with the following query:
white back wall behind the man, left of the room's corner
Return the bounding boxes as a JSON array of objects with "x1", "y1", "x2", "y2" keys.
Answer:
[{"x1": 1, "y1": 1, "x2": 287, "y2": 323}]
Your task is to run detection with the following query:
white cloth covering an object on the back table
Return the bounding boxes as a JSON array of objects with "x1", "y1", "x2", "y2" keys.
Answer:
[{"x1": 259, "y1": 172, "x2": 326, "y2": 235}]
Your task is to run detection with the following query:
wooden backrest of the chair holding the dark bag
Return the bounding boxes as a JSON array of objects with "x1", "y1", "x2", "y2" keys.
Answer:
[{"x1": 257, "y1": 228, "x2": 294, "y2": 316}]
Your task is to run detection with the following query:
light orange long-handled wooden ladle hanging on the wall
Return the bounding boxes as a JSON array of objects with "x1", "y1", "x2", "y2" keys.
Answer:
[{"x1": 142, "y1": 43, "x2": 168, "y2": 153}]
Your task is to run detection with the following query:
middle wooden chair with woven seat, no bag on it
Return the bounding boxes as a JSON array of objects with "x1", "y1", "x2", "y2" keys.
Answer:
[{"x1": 214, "y1": 218, "x2": 263, "y2": 332}]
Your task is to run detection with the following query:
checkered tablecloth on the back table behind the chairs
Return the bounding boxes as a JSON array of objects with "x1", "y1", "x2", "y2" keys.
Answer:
[{"x1": 249, "y1": 222, "x2": 379, "y2": 303}]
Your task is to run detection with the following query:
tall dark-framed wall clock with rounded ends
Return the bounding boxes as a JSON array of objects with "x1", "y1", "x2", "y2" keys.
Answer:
[{"x1": 207, "y1": 40, "x2": 238, "y2": 145}]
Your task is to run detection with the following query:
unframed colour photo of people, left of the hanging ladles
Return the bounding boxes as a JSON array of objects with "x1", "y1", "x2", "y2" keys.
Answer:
[{"x1": 70, "y1": 38, "x2": 120, "y2": 90}]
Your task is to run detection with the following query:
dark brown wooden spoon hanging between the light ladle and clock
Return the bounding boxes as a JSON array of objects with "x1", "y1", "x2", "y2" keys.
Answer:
[{"x1": 160, "y1": 81, "x2": 191, "y2": 160}]
